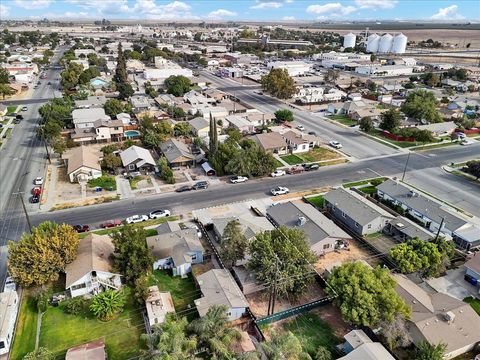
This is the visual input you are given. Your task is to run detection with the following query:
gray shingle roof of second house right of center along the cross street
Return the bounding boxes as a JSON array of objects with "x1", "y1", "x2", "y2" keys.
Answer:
[{"x1": 324, "y1": 188, "x2": 393, "y2": 226}]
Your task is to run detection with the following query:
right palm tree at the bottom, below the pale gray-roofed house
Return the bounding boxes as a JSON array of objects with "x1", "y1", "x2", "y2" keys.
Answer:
[{"x1": 190, "y1": 305, "x2": 242, "y2": 359}]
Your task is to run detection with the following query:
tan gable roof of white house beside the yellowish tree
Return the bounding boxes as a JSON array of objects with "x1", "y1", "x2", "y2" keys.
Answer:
[{"x1": 65, "y1": 233, "x2": 114, "y2": 289}]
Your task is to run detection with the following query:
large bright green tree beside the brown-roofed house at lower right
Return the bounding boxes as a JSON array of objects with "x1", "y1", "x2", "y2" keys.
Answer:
[{"x1": 327, "y1": 262, "x2": 410, "y2": 326}]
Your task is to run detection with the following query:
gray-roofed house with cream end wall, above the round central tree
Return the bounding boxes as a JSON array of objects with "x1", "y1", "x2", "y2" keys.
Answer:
[{"x1": 267, "y1": 201, "x2": 351, "y2": 256}]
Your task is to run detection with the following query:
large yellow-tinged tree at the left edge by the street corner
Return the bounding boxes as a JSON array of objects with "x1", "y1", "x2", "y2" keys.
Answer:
[{"x1": 8, "y1": 221, "x2": 80, "y2": 287}]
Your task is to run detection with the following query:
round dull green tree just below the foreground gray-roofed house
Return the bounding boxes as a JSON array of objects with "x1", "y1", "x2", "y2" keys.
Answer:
[{"x1": 247, "y1": 226, "x2": 316, "y2": 297}]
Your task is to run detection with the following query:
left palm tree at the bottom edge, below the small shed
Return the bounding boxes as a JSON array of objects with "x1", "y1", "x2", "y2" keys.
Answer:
[{"x1": 141, "y1": 314, "x2": 197, "y2": 360}]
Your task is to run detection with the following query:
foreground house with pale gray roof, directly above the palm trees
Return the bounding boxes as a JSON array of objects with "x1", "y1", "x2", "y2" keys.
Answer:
[{"x1": 195, "y1": 269, "x2": 248, "y2": 321}]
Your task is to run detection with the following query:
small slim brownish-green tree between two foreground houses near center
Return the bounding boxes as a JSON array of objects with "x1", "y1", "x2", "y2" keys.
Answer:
[{"x1": 220, "y1": 220, "x2": 248, "y2": 267}]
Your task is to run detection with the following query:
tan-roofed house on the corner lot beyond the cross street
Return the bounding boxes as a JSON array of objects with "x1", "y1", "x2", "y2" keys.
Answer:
[{"x1": 62, "y1": 145, "x2": 102, "y2": 183}]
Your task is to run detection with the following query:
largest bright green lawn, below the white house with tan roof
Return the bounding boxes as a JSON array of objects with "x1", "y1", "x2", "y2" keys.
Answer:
[{"x1": 40, "y1": 287, "x2": 145, "y2": 360}]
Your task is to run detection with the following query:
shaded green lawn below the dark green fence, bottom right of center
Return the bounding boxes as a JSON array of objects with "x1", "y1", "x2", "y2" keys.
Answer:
[{"x1": 283, "y1": 311, "x2": 341, "y2": 356}]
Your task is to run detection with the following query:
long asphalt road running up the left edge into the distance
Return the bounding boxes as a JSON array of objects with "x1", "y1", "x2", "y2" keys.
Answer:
[{"x1": 0, "y1": 49, "x2": 65, "y2": 289}]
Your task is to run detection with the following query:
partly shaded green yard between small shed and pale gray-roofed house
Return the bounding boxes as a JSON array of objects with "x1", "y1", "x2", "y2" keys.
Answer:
[{"x1": 148, "y1": 270, "x2": 201, "y2": 318}]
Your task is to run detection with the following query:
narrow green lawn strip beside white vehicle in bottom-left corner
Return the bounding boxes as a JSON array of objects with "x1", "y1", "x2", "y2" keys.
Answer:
[{"x1": 10, "y1": 290, "x2": 38, "y2": 360}]
